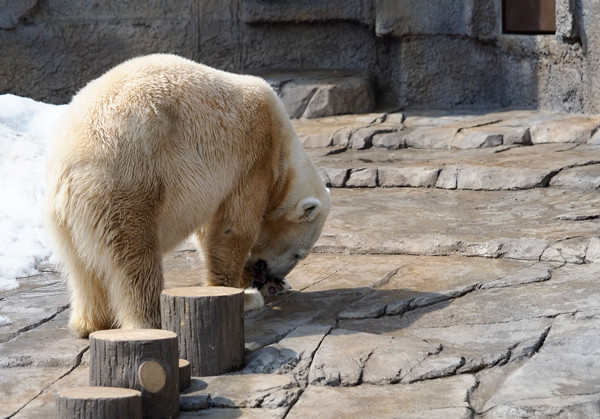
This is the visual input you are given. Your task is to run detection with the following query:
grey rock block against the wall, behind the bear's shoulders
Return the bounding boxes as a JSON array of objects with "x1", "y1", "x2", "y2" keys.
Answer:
[{"x1": 256, "y1": 70, "x2": 375, "y2": 118}]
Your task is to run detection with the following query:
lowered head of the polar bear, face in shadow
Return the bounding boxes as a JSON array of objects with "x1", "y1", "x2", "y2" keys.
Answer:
[{"x1": 248, "y1": 192, "x2": 331, "y2": 279}]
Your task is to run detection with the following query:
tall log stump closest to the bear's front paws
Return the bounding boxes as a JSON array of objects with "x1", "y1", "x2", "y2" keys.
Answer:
[{"x1": 160, "y1": 287, "x2": 244, "y2": 376}]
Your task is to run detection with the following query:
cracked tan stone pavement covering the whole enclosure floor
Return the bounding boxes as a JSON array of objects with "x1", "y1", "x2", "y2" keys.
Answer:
[{"x1": 0, "y1": 111, "x2": 600, "y2": 418}]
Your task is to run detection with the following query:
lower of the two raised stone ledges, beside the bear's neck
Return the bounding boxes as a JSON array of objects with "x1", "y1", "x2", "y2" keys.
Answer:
[{"x1": 309, "y1": 144, "x2": 600, "y2": 190}]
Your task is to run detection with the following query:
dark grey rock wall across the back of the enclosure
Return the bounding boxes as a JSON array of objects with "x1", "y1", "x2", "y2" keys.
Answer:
[{"x1": 0, "y1": 0, "x2": 600, "y2": 113}]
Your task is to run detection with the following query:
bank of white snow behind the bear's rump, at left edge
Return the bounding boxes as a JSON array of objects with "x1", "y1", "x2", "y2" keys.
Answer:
[{"x1": 0, "y1": 94, "x2": 66, "y2": 292}]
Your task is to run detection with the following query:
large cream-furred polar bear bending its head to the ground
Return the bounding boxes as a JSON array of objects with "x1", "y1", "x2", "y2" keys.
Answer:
[{"x1": 45, "y1": 54, "x2": 330, "y2": 337}]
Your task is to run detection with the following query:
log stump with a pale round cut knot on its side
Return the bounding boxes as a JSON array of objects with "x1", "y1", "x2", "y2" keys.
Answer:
[{"x1": 90, "y1": 329, "x2": 179, "y2": 418}]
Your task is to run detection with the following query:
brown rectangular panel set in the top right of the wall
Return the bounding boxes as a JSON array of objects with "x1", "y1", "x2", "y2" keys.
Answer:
[{"x1": 502, "y1": 0, "x2": 556, "y2": 34}]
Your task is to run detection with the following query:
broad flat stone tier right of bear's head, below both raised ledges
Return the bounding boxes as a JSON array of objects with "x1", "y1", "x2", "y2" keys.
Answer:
[{"x1": 314, "y1": 188, "x2": 600, "y2": 264}]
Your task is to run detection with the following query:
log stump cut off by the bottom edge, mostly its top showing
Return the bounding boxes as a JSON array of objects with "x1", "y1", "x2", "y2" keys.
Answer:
[{"x1": 56, "y1": 387, "x2": 142, "y2": 419}]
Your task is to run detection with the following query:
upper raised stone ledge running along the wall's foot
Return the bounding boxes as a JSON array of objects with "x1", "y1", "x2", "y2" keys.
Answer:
[{"x1": 294, "y1": 110, "x2": 600, "y2": 150}]
